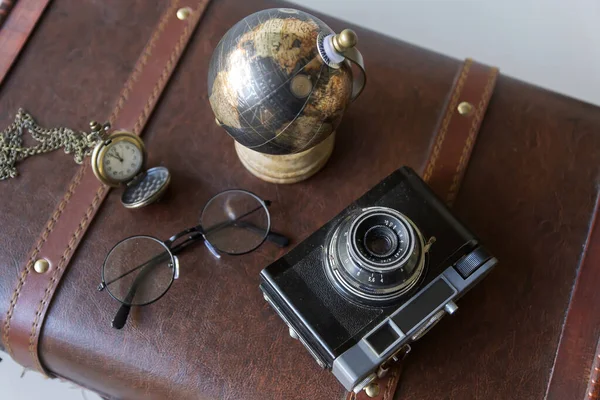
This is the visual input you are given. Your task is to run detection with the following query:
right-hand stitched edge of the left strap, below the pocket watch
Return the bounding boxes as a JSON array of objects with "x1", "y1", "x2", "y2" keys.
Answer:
[{"x1": 29, "y1": 185, "x2": 107, "y2": 372}]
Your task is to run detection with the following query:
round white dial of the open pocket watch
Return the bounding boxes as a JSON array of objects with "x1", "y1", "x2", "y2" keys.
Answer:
[{"x1": 102, "y1": 140, "x2": 144, "y2": 182}]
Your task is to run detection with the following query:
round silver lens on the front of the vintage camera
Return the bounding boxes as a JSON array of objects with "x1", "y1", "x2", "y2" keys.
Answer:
[{"x1": 326, "y1": 207, "x2": 425, "y2": 304}]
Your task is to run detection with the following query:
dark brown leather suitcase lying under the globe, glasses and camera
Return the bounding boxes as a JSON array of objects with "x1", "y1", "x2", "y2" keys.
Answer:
[{"x1": 0, "y1": 0, "x2": 600, "y2": 400}]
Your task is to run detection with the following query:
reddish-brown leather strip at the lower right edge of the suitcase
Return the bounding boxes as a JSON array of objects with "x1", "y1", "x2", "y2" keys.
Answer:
[{"x1": 546, "y1": 192, "x2": 600, "y2": 400}]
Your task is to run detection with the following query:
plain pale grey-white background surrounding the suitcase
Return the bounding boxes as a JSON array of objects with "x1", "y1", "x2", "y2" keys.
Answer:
[{"x1": 0, "y1": 0, "x2": 600, "y2": 400}]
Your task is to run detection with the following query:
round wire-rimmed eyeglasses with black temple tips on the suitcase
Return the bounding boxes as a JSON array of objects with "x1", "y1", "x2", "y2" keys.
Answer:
[{"x1": 98, "y1": 189, "x2": 289, "y2": 329}]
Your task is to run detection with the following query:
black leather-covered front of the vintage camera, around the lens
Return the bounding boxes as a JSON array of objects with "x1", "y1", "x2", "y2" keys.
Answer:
[{"x1": 261, "y1": 167, "x2": 478, "y2": 368}]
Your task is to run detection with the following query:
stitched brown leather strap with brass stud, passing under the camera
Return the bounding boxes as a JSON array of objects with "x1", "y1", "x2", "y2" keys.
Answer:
[{"x1": 346, "y1": 58, "x2": 498, "y2": 400}]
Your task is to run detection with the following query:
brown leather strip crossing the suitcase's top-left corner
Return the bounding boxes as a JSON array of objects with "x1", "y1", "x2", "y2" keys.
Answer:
[{"x1": 0, "y1": 0, "x2": 50, "y2": 84}]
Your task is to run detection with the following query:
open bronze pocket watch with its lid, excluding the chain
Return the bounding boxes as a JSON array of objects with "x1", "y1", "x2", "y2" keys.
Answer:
[{"x1": 90, "y1": 122, "x2": 171, "y2": 208}]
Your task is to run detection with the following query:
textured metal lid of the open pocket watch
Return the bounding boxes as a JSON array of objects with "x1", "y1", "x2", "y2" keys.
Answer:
[{"x1": 121, "y1": 167, "x2": 171, "y2": 208}]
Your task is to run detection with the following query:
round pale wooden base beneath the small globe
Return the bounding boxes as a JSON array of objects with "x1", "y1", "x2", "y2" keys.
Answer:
[{"x1": 235, "y1": 132, "x2": 335, "y2": 183}]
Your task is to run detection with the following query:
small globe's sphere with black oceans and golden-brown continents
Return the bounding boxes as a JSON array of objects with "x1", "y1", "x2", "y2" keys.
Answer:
[{"x1": 208, "y1": 8, "x2": 352, "y2": 155}]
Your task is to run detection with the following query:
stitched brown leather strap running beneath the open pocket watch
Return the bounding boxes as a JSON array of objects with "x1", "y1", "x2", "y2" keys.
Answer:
[{"x1": 3, "y1": 0, "x2": 208, "y2": 374}]
